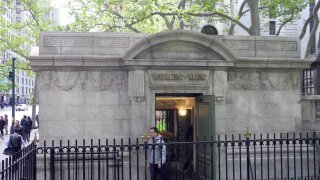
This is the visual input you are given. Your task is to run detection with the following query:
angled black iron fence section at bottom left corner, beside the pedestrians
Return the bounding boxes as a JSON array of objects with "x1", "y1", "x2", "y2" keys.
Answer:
[{"x1": 0, "y1": 143, "x2": 37, "y2": 180}]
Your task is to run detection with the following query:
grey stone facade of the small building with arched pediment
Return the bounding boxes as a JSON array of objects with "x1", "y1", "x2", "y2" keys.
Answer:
[{"x1": 28, "y1": 31, "x2": 310, "y2": 140}]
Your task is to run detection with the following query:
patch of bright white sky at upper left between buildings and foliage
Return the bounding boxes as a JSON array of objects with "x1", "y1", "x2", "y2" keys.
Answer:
[{"x1": 51, "y1": 0, "x2": 73, "y2": 25}]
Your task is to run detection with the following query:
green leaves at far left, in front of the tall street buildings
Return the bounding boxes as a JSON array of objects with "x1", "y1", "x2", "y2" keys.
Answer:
[{"x1": 0, "y1": 0, "x2": 56, "y2": 92}]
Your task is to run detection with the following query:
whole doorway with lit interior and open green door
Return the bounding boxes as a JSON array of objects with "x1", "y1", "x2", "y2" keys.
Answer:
[{"x1": 154, "y1": 94, "x2": 215, "y2": 179}]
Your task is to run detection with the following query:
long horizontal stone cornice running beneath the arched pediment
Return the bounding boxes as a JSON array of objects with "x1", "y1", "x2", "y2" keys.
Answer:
[{"x1": 27, "y1": 55, "x2": 312, "y2": 71}]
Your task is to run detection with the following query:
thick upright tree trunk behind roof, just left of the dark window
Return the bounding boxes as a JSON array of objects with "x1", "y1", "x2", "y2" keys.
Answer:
[{"x1": 247, "y1": 0, "x2": 260, "y2": 36}]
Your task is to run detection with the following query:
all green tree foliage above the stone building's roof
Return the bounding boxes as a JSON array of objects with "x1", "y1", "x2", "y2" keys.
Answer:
[{"x1": 65, "y1": 0, "x2": 311, "y2": 33}]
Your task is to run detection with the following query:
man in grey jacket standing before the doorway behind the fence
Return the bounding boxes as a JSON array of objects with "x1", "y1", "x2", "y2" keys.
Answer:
[{"x1": 148, "y1": 127, "x2": 169, "y2": 180}]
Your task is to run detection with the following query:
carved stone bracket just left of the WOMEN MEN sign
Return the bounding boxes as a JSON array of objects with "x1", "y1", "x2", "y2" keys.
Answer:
[{"x1": 133, "y1": 70, "x2": 144, "y2": 102}]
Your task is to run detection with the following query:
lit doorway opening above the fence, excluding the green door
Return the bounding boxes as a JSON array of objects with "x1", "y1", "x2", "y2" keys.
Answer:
[{"x1": 154, "y1": 94, "x2": 196, "y2": 142}]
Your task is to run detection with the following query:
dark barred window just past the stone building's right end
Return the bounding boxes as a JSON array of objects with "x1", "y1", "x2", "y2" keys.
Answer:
[{"x1": 302, "y1": 69, "x2": 314, "y2": 95}]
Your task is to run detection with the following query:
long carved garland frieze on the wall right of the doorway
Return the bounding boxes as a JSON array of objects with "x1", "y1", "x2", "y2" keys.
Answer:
[{"x1": 229, "y1": 71, "x2": 300, "y2": 90}]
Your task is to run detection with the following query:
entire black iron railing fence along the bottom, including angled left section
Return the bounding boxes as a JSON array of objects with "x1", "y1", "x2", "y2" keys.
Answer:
[{"x1": 0, "y1": 133, "x2": 320, "y2": 180}]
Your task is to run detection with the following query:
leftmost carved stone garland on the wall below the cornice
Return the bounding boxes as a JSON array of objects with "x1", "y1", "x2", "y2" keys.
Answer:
[{"x1": 53, "y1": 71, "x2": 80, "y2": 91}]
